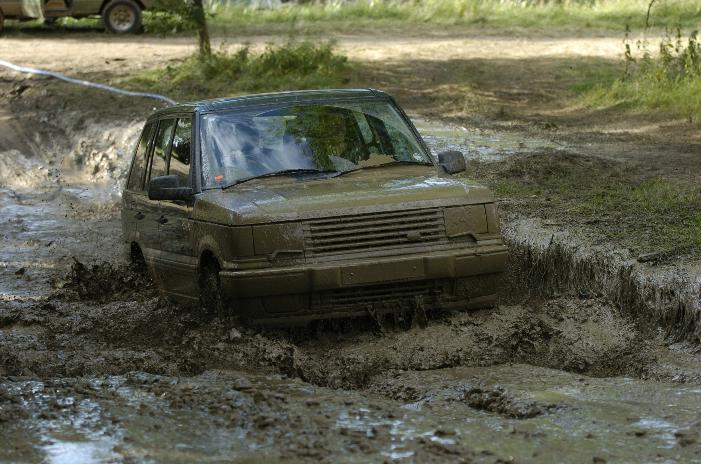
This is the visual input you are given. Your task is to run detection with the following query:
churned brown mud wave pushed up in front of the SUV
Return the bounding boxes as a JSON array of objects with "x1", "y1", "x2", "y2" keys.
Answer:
[{"x1": 0, "y1": 263, "x2": 668, "y2": 389}]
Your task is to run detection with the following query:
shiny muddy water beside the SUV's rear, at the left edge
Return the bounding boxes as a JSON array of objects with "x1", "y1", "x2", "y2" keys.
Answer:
[{"x1": 0, "y1": 187, "x2": 122, "y2": 301}]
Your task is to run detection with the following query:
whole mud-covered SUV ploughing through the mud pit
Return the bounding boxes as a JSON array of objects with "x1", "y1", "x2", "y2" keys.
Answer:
[{"x1": 122, "y1": 90, "x2": 507, "y2": 325}]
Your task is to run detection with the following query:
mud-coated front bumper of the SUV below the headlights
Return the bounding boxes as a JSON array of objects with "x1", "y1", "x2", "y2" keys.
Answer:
[{"x1": 220, "y1": 244, "x2": 508, "y2": 320}]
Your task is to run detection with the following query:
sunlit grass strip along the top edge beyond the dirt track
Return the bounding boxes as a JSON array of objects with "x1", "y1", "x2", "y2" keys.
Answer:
[{"x1": 212, "y1": 0, "x2": 701, "y2": 30}]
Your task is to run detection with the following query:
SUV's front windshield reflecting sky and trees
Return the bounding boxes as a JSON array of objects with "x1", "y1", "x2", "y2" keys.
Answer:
[{"x1": 201, "y1": 101, "x2": 431, "y2": 188}]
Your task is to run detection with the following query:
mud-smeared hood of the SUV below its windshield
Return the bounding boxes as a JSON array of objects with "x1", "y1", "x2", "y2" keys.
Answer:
[{"x1": 193, "y1": 166, "x2": 494, "y2": 225}]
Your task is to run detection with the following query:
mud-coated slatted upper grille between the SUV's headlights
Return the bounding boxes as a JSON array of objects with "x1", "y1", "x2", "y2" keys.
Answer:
[{"x1": 304, "y1": 208, "x2": 446, "y2": 255}]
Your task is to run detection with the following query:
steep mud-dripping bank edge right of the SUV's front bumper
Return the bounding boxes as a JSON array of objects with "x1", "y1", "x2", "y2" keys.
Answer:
[{"x1": 504, "y1": 218, "x2": 701, "y2": 343}]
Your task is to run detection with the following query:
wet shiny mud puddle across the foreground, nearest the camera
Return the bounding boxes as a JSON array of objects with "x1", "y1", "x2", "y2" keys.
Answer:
[{"x1": 0, "y1": 364, "x2": 701, "y2": 463}]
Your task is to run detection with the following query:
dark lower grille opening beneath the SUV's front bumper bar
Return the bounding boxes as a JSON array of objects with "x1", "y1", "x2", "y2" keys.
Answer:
[{"x1": 312, "y1": 281, "x2": 443, "y2": 308}]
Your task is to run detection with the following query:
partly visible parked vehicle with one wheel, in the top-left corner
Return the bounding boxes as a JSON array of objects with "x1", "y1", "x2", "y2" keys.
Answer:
[{"x1": 0, "y1": 0, "x2": 148, "y2": 34}]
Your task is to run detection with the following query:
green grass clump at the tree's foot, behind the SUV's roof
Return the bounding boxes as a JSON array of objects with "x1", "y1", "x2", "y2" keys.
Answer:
[{"x1": 126, "y1": 41, "x2": 351, "y2": 101}]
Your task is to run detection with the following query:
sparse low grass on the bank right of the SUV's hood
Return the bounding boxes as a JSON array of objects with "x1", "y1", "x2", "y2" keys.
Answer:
[{"x1": 468, "y1": 153, "x2": 701, "y2": 255}]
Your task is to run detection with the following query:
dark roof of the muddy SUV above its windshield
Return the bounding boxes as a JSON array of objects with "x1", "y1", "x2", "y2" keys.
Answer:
[{"x1": 149, "y1": 89, "x2": 389, "y2": 119}]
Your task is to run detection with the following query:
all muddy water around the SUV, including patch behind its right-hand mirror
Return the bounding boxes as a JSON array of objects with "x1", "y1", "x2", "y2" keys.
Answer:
[{"x1": 0, "y1": 110, "x2": 701, "y2": 463}]
